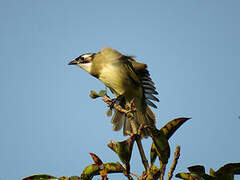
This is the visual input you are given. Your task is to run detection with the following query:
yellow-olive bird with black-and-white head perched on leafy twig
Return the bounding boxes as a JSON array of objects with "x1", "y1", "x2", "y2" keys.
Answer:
[{"x1": 69, "y1": 47, "x2": 159, "y2": 138}]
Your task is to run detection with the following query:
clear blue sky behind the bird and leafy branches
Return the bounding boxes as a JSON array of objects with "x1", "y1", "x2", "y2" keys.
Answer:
[{"x1": 0, "y1": 0, "x2": 240, "y2": 180}]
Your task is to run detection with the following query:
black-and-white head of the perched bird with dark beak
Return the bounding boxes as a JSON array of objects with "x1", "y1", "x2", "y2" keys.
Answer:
[{"x1": 68, "y1": 53, "x2": 95, "y2": 73}]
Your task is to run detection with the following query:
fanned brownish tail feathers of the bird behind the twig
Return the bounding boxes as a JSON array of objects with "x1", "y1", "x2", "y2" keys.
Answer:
[{"x1": 111, "y1": 106, "x2": 156, "y2": 138}]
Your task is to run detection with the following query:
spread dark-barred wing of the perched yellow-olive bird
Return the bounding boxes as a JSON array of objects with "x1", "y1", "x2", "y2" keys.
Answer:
[{"x1": 129, "y1": 57, "x2": 159, "y2": 108}]
